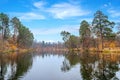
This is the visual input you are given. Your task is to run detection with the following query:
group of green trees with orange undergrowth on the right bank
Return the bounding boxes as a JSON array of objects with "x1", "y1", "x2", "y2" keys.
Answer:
[{"x1": 61, "y1": 10, "x2": 120, "y2": 51}]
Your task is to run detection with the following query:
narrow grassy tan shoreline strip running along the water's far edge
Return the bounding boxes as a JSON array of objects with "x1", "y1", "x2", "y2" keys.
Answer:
[{"x1": 0, "y1": 48, "x2": 120, "y2": 54}]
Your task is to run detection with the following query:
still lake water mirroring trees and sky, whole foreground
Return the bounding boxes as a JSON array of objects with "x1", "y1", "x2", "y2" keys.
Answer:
[{"x1": 0, "y1": 53, "x2": 120, "y2": 80}]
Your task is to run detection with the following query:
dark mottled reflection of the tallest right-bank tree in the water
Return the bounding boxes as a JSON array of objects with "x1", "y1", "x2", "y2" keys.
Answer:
[{"x1": 95, "y1": 54, "x2": 119, "y2": 80}]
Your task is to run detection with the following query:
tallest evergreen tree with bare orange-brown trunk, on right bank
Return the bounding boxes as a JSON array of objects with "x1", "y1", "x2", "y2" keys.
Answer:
[{"x1": 92, "y1": 10, "x2": 115, "y2": 50}]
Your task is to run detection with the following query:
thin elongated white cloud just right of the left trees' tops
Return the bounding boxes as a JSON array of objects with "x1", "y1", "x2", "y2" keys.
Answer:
[{"x1": 18, "y1": 12, "x2": 45, "y2": 20}]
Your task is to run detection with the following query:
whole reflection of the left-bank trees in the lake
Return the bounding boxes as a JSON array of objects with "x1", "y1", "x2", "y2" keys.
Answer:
[{"x1": 0, "y1": 53, "x2": 32, "y2": 80}]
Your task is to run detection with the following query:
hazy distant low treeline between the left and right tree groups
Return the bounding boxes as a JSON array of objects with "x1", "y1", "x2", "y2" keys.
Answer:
[{"x1": 32, "y1": 41, "x2": 65, "y2": 52}]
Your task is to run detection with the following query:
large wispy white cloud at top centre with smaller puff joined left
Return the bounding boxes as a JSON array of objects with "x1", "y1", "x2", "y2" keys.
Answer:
[{"x1": 33, "y1": 1, "x2": 90, "y2": 19}]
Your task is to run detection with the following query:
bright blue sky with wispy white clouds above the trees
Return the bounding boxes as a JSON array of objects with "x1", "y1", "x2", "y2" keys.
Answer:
[{"x1": 0, "y1": 0, "x2": 120, "y2": 42}]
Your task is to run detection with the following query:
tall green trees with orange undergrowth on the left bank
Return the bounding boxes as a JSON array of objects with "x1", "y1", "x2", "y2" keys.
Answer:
[{"x1": 0, "y1": 13, "x2": 34, "y2": 51}]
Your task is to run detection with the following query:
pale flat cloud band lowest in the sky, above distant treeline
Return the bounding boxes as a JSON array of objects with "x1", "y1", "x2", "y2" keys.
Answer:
[{"x1": 31, "y1": 25, "x2": 79, "y2": 35}]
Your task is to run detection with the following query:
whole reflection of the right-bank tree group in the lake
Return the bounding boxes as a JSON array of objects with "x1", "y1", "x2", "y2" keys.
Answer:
[{"x1": 61, "y1": 52, "x2": 120, "y2": 80}]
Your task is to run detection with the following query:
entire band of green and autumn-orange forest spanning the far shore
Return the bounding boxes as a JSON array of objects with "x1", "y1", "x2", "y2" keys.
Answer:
[{"x1": 0, "y1": 10, "x2": 120, "y2": 52}]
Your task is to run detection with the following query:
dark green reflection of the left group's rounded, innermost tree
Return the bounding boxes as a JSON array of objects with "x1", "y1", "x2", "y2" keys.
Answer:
[{"x1": 11, "y1": 54, "x2": 32, "y2": 80}]
